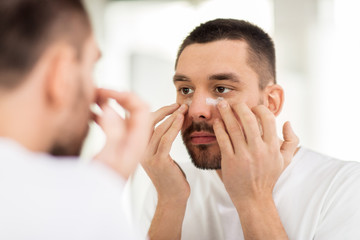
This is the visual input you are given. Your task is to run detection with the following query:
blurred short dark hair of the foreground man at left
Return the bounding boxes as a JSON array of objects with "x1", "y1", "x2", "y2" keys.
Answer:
[{"x1": 0, "y1": 0, "x2": 90, "y2": 88}]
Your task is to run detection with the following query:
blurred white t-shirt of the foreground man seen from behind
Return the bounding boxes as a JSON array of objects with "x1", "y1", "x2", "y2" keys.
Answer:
[{"x1": 0, "y1": 138, "x2": 143, "y2": 240}]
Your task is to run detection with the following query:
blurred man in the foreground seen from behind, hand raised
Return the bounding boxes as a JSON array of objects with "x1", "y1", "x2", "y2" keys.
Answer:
[{"x1": 0, "y1": 0, "x2": 150, "y2": 240}]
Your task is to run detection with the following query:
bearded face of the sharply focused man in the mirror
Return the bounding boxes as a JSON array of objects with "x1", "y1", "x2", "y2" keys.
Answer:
[{"x1": 174, "y1": 40, "x2": 262, "y2": 169}]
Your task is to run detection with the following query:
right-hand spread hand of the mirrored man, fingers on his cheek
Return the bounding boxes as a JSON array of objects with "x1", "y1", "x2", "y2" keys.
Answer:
[{"x1": 214, "y1": 101, "x2": 298, "y2": 204}]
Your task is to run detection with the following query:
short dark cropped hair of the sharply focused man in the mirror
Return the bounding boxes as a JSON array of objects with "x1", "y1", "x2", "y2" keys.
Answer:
[{"x1": 175, "y1": 19, "x2": 276, "y2": 89}]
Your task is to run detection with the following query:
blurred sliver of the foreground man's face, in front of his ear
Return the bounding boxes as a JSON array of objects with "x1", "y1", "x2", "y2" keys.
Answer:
[{"x1": 51, "y1": 36, "x2": 100, "y2": 156}]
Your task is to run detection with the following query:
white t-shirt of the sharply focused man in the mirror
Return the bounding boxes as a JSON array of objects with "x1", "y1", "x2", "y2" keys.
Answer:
[{"x1": 129, "y1": 148, "x2": 360, "y2": 240}]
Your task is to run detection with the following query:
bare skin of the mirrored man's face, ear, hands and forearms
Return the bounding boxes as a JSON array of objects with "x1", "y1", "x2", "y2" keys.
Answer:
[{"x1": 143, "y1": 40, "x2": 298, "y2": 239}]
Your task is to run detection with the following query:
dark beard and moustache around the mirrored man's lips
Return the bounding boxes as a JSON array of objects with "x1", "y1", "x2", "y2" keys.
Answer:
[{"x1": 181, "y1": 122, "x2": 221, "y2": 169}]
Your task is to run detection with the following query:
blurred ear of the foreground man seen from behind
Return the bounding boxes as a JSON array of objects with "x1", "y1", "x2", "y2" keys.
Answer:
[{"x1": 42, "y1": 43, "x2": 76, "y2": 109}]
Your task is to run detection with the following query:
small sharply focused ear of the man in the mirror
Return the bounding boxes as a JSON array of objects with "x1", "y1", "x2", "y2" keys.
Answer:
[{"x1": 264, "y1": 84, "x2": 284, "y2": 116}]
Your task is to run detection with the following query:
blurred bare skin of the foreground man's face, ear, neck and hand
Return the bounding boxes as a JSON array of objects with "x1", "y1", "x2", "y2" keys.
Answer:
[{"x1": 0, "y1": 33, "x2": 150, "y2": 179}]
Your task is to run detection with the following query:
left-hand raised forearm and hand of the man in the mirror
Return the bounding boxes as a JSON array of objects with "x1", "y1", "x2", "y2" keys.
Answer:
[{"x1": 142, "y1": 105, "x2": 190, "y2": 240}]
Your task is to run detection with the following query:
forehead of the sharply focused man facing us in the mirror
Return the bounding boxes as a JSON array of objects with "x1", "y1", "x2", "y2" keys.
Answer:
[{"x1": 173, "y1": 39, "x2": 253, "y2": 82}]
